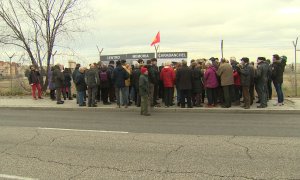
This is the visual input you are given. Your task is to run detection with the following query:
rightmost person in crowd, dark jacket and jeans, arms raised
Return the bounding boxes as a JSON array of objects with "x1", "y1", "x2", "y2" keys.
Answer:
[{"x1": 272, "y1": 54, "x2": 287, "y2": 106}]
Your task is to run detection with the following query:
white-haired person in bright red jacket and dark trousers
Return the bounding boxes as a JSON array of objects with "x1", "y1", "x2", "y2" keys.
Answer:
[{"x1": 160, "y1": 62, "x2": 176, "y2": 107}]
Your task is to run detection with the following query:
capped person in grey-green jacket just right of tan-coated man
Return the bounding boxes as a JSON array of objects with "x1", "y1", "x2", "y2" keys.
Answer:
[{"x1": 238, "y1": 57, "x2": 251, "y2": 109}]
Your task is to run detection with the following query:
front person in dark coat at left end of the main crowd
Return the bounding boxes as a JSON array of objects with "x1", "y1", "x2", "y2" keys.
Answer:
[{"x1": 52, "y1": 64, "x2": 65, "y2": 104}]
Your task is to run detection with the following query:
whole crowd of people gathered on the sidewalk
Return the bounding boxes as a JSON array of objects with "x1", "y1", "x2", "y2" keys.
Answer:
[{"x1": 28, "y1": 54, "x2": 287, "y2": 115}]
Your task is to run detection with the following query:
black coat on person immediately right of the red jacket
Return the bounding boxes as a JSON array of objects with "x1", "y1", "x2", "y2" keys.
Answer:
[{"x1": 176, "y1": 66, "x2": 193, "y2": 90}]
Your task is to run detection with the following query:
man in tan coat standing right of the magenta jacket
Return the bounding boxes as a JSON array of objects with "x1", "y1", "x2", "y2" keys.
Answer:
[{"x1": 217, "y1": 59, "x2": 234, "y2": 108}]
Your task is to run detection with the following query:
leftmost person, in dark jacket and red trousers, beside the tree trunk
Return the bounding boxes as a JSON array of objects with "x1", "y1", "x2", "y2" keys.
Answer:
[{"x1": 28, "y1": 65, "x2": 43, "y2": 100}]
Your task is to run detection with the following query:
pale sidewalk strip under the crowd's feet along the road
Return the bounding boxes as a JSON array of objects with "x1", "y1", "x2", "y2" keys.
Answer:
[{"x1": 0, "y1": 96, "x2": 300, "y2": 114}]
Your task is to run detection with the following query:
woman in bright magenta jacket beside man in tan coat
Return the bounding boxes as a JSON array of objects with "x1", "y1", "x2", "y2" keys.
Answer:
[{"x1": 204, "y1": 61, "x2": 219, "y2": 108}]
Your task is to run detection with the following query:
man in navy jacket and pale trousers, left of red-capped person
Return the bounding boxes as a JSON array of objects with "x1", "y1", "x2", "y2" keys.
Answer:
[{"x1": 112, "y1": 61, "x2": 129, "y2": 108}]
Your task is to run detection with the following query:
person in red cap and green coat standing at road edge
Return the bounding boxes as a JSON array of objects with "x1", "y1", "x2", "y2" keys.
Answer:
[{"x1": 139, "y1": 67, "x2": 150, "y2": 116}]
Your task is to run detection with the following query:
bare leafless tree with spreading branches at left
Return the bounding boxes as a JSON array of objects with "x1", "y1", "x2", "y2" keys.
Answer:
[{"x1": 0, "y1": 0, "x2": 84, "y2": 90}]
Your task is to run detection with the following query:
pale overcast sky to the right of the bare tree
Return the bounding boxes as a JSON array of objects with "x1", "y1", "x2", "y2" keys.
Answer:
[{"x1": 3, "y1": 0, "x2": 300, "y2": 62}]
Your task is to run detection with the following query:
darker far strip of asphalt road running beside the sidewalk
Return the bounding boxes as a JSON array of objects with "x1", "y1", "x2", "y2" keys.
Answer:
[{"x1": 0, "y1": 109, "x2": 300, "y2": 137}]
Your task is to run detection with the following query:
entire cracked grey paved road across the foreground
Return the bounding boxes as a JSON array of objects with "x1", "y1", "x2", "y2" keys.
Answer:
[{"x1": 0, "y1": 109, "x2": 300, "y2": 180}]
